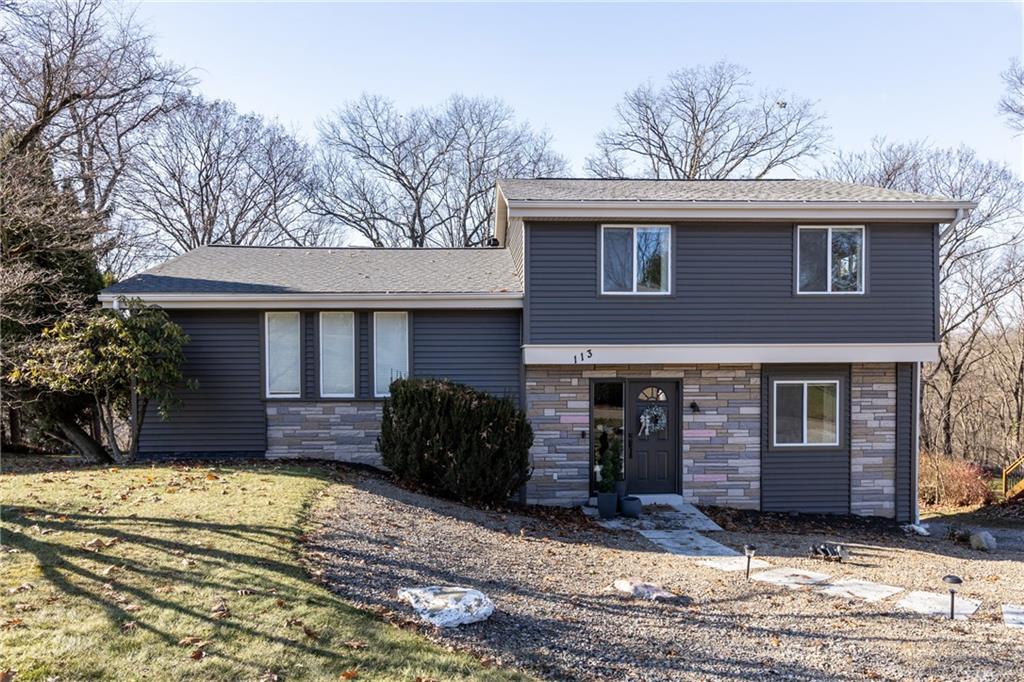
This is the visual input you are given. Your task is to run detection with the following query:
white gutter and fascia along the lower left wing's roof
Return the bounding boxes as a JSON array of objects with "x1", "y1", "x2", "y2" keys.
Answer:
[{"x1": 98, "y1": 292, "x2": 523, "y2": 310}]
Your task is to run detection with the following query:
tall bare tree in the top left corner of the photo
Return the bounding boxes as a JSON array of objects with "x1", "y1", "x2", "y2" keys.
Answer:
[{"x1": 0, "y1": 0, "x2": 193, "y2": 275}]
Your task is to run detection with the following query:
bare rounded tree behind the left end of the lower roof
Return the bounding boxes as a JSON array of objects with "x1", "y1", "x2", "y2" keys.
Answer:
[{"x1": 123, "y1": 97, "x2": 323, "y2": 253}]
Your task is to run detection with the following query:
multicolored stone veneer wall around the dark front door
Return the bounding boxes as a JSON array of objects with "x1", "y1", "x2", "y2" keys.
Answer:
[{"x1": 526, "y1": 365, "x2": 761, "y2": 509}]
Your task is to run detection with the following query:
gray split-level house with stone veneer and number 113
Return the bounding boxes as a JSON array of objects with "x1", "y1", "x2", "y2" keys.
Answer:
[{"x1": 101, "y1": 179, "x2": 973, "y2": 521}]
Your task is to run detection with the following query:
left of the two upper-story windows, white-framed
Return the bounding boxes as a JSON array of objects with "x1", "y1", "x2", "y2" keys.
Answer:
[{"x1": 601, "y1": 225, "x2": 672, "y2": 294}]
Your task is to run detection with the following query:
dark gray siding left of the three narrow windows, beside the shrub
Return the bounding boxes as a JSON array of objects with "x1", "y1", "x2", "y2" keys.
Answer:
[{"x1": 139, "y1": 310, "x2": 266, "y2": 456}]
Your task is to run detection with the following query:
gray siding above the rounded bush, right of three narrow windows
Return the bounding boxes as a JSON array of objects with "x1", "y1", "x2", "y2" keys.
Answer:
[{"x1": 413, "y1": 310, "x2": 521, "y2": 398}]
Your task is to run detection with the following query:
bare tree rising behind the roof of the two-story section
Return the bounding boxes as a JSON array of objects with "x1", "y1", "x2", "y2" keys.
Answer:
[{"x1": 587, "y1": 61, "x2": 827, "y2": 180}]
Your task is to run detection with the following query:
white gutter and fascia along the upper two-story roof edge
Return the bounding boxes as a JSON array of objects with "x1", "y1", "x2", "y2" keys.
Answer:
[{"x1": 499, "y1": 196, "x2": 977, "y2": 222}]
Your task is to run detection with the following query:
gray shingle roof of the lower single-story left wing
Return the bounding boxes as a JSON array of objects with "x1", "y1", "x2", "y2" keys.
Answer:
[{"x1": 103, "y1": 246, "x2": 522, "y2": 295}]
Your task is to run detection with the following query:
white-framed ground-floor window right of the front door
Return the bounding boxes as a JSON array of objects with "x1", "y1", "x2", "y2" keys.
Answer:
[{"x1": 772, "y1": 380, "x2": 839, "y2": 447}]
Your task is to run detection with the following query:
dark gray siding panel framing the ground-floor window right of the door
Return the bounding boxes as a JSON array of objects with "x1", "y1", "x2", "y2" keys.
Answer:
[{"x1": 761, "y1": 365, "x2": 850, "y2": 514}]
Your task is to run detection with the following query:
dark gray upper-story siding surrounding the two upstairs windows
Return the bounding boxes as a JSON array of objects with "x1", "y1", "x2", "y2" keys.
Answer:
[{"x1": 524, "y1": 222, "x2": 937, "y2": 344}]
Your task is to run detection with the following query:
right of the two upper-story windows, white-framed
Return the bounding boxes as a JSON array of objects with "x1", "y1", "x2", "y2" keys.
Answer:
[{"x1": 797, "y1": 226, "x2": 864, "y2": 294}]
